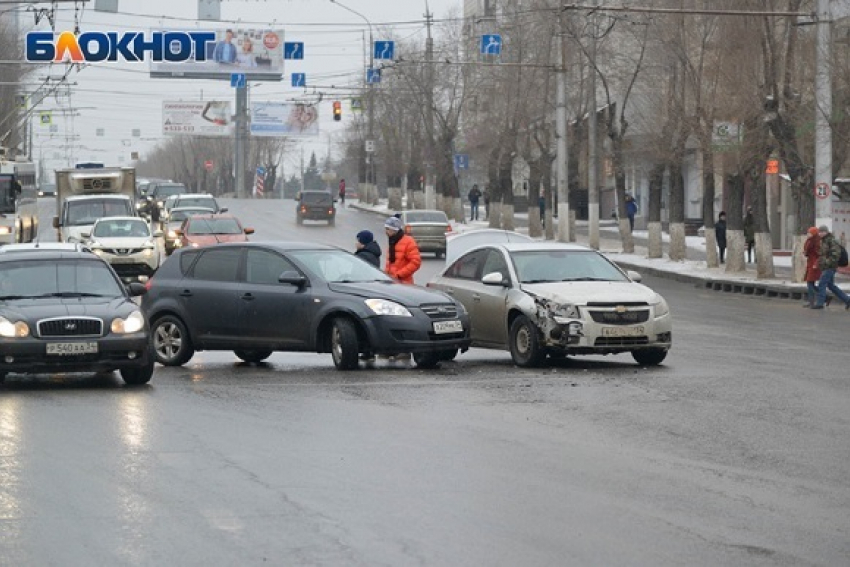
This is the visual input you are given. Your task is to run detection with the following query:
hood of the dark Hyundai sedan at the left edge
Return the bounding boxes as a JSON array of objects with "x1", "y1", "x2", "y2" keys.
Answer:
[{"x1": 0, "y1": 297, "x2": 139, "y2": 325}]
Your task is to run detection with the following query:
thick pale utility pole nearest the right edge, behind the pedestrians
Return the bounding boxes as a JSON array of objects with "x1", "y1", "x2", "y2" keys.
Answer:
[{"x1": 814, "y1": 0, "x2": 832, "y2": 230}]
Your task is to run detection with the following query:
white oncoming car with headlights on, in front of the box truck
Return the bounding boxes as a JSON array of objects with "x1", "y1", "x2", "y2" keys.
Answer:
[{"x1": 82, "y1": 217, "x2": 162, "y2": 279}]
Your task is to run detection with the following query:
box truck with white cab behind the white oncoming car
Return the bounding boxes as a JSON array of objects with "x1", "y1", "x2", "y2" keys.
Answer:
[{"x1": 53, "y1": 167, "x2": 136, "y2": 242}]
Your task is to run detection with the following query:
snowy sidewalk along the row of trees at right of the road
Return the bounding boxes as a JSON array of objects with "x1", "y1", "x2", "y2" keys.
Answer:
[{"x1": 348, "y1": 200, "x2": 850, "y2": 306}]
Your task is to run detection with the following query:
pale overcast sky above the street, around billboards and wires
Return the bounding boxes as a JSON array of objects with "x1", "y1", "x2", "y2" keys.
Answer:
[{"x1": 26, "y1": 0, "x2": 462, "y2": 172}]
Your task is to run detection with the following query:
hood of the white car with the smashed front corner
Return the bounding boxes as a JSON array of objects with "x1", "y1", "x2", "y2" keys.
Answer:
[{"x1": 522, "y1": 282, "x2": 656, "y2": 305}]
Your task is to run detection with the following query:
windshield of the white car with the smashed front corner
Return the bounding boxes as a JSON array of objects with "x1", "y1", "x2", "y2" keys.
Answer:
[{"x1": 511, "y1": 250, "x2": 629, "y2": 283}]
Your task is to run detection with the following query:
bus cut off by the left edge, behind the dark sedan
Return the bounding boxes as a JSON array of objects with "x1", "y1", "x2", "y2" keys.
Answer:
[{"x1": 0, "y1": 158, "x2": 38, "y2": 246}]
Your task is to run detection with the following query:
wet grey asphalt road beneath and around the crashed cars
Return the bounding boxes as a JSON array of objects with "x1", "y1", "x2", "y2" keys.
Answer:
[{"x1": 0, "y1": 197, "x2": 850, "y2": 566}]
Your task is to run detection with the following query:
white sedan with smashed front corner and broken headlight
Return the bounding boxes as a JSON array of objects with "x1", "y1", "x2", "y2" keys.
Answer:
[{"x1": 428, "y1": 236, "x2": 673, "y2": 367}]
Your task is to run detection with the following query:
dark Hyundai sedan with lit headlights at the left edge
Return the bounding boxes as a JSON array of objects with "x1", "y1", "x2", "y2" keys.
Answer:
[{"x1": 0, "y1": 248, "x2": 154, "y2": 384}]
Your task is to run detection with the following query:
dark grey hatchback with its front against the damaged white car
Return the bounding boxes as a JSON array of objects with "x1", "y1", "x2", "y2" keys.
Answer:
[{"x1": 142, "y1": 242, "x2": 470, "y2": 370}]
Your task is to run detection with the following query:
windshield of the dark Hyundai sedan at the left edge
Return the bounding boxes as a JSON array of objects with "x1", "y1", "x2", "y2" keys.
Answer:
[{"x1": 0, "y1": 259, "x2": 124, "y2": 301}]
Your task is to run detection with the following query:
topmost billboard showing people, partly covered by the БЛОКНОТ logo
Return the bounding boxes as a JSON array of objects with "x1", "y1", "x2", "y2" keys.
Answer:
[{"x1": 150, "y1": 27, "x2": 284, "y2": 81}]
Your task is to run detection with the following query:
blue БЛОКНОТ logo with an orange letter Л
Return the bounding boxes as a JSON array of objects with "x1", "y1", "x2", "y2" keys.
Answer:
[{"x1": 26, "y1": 31, "x2": 215, "y2": 63}]
